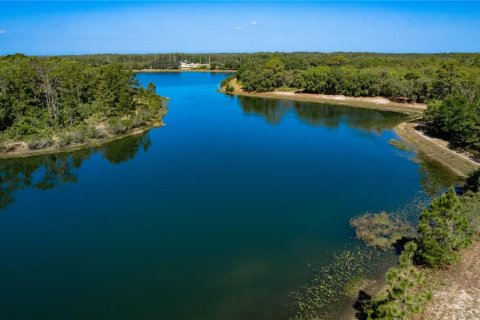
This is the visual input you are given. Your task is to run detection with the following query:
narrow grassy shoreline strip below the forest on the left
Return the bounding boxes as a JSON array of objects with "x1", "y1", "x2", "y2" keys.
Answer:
[{"x1": 0, "y1": 120, "x2": 165, "y2": 160}]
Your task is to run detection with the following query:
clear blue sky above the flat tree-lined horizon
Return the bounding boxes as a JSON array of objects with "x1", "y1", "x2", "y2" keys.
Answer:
[{"x1": 0, "y1": 0, "x2": 480, "y2": 55}]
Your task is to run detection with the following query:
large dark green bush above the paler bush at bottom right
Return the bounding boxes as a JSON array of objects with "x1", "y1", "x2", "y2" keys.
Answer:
[{"x1": 416, "y1": 188, "x2": 475, "y2": 269}]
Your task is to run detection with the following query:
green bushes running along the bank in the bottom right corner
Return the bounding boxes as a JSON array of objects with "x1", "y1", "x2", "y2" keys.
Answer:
[{"x1": 363, "y1": 178, "x2": 480, "y2": 320}]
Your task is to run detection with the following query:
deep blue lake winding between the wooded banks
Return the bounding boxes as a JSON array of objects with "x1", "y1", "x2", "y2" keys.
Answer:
[{"x1": 0, "y1": 72, "x2": 455, "y2": 320}]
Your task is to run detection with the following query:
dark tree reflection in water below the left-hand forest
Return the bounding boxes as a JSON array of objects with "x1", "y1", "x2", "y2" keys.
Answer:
[{"x1": 0, "y1": 133, "x2": 151, "y2": 209}]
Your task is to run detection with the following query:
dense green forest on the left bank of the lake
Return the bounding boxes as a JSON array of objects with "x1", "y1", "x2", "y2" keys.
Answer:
[{"x1": 0, "y1": 55, "x2": 165, "y2": 152}]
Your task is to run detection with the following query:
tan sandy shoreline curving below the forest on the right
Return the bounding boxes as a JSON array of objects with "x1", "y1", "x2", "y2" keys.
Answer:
[{"x1": 221, "y1": 78, "x2": 480, "y2": 178}]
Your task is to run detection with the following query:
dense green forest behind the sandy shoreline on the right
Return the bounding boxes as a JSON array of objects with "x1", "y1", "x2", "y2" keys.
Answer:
[{"x1": 233, "y1": 53, "x2": 480, "y2": 156}]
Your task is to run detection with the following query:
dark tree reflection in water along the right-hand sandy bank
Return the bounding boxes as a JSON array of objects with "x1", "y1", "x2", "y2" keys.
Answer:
[{"x1": 238, "y1": 96, "x2": 405, "y2": 130}]
